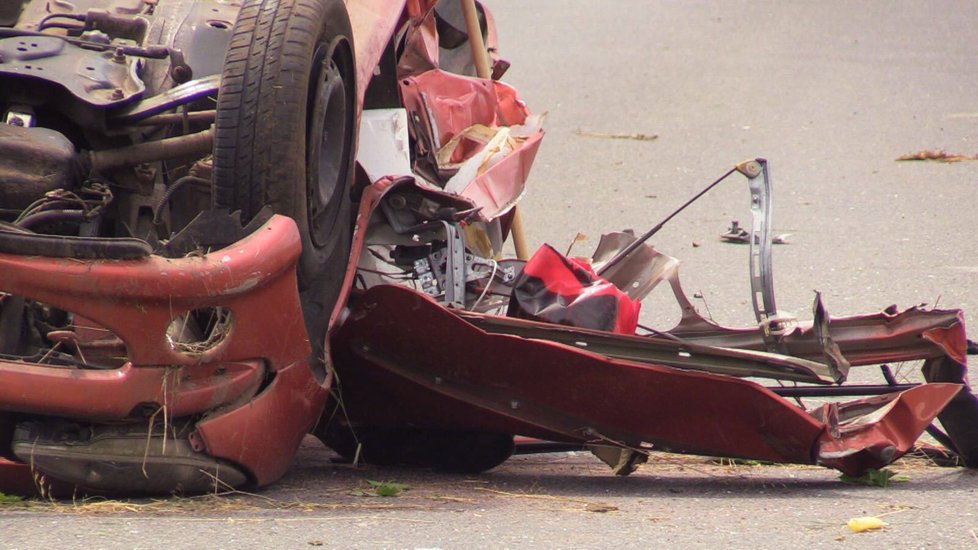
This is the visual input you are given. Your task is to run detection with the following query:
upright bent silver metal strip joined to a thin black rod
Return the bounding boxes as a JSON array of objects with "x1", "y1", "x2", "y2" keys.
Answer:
[{"x1": 737, "y1": 158, "x2": 781, "y2": 332}]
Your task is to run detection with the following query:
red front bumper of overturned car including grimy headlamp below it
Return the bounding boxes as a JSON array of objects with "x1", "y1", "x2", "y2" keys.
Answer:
[{"x1": 0, "y1": 216, "x2": 329, "y2": 491}]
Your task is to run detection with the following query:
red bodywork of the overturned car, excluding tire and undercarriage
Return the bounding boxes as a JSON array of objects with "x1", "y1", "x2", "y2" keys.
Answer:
[{"x1": 0, "y1": 0, "x2": 978, "y2": 493}]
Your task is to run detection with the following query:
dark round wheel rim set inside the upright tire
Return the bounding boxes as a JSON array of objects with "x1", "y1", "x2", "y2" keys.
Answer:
[{"x1": 306, "y1": 45, "x2": 351, "y2": 248}]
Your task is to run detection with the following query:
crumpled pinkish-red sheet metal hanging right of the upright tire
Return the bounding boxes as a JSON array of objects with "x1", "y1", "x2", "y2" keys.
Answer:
[{"x1": 391, "y1": 6, "x2": 543, "y2": 221}]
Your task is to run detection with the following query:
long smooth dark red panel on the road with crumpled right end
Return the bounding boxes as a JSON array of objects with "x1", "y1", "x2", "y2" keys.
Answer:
[{"x1": 332, "y1": 285, "x2": 962, "y2": 470}]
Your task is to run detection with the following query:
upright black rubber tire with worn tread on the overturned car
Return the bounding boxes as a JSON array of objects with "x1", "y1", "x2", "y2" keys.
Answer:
[{"x1": 213, "y1": 0, "x2": 356, "y2": 376}]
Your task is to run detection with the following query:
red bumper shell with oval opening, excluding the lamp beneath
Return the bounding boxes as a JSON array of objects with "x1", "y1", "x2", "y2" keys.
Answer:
[{"x1": 0, "y1": 216, "x2": 329, "y2": 490}]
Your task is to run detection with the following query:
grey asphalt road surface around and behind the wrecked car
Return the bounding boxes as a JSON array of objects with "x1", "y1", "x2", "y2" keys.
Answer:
[{"x1": 0, "y1": 0, "x2": 978, "y2": 548}]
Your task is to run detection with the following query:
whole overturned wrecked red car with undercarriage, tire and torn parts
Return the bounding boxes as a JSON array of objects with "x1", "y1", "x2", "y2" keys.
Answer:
[{"x1": 0, "y1": 0, "x2": 978, "y2": 493}]
